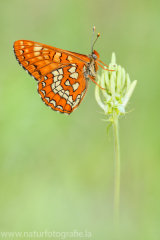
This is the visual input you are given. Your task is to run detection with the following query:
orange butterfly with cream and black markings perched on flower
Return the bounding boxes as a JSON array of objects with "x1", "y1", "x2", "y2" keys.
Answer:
[{"x1": 13, "y1": 27, "x2": 107, "y2": 114}]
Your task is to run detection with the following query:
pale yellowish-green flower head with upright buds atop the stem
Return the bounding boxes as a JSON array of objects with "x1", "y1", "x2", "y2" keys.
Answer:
[{"x1": 95, "y1": 53, "x2": 137, "y2": 122}]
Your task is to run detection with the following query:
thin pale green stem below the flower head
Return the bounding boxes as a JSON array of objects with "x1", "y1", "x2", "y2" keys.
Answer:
[{"x1": 113, "y1": 109, "x2": 120, "y2": 227}]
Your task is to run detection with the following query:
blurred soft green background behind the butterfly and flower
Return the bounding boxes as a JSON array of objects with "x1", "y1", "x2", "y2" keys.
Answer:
[{"x1": 0, "y1": 0, "x2": 160, "y2": 240}]
